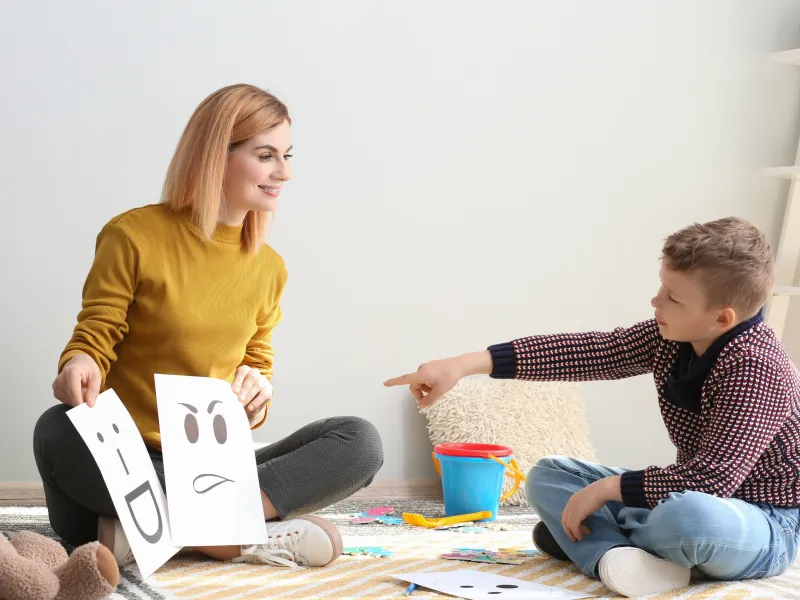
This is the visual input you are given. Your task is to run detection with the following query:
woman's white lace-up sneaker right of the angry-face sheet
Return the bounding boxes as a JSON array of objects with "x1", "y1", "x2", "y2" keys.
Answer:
[{"x1": 233, "y1": 516, "x2": 342, "y2": 568}]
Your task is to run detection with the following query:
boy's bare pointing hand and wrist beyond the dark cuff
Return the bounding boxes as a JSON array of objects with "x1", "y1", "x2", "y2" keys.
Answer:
[{"x1": 383, "y1": 350, "x2": 492, "y2": 408}]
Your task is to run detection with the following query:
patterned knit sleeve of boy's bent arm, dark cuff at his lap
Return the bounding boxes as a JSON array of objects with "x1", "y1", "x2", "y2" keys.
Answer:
[{"x1": 621, "y1": 355, "x2": 791, "y2": 508}]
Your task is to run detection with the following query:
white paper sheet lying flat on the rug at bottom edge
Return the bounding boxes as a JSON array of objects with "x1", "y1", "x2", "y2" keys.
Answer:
[{"x1": 392, "y1": 569, "x2": 595, "y2": 600}]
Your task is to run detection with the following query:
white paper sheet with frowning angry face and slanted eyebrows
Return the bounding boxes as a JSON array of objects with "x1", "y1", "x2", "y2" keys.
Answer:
[{"x1": 155, "y1": 374, "x2": 268, "y2": 547}]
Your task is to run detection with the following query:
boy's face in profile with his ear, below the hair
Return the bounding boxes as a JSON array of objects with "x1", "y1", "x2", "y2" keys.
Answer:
[{"x1": 650, "y1": 265, "x2": 736, "y2": 354}]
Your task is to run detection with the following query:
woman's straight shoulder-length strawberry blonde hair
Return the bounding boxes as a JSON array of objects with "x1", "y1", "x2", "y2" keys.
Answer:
[{"x1": 161, "y1": 84, "x2": 292, "y2": 252}]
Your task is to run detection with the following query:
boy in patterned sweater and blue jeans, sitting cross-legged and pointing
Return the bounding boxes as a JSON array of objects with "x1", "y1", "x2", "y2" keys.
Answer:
[{"x1": 385, "y1": 218, "x2": 800, "y2": 596}]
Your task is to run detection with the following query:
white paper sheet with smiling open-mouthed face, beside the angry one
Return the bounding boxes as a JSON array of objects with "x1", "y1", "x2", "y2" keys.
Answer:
[{"x1": 67, "y1": 390, "x2": 180, "y2": 578}]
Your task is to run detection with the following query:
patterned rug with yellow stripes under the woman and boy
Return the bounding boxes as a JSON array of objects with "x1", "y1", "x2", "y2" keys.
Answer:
[{"x1": 0, "y1": 500, "x2": 800, "y2": 600}]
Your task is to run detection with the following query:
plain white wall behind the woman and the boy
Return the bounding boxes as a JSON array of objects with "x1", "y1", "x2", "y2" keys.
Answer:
[{"x1": 0, "y1": 0, "x2": 800, "y2": 481}]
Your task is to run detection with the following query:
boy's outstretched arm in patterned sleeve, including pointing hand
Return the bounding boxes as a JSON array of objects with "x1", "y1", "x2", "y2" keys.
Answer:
[{"x1": 384, "y1": 319, "x2": 663, "y2": 408}]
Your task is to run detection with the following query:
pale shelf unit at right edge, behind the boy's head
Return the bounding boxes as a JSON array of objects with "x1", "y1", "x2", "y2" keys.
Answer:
[{"x1": 764, "y1": 48, "x2": 800, "y2": 339}]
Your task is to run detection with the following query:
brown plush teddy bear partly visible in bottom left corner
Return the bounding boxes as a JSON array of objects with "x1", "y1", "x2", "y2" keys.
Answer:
[{"x1": 0, "y1": 531, "x2": 119, "y2": 600}]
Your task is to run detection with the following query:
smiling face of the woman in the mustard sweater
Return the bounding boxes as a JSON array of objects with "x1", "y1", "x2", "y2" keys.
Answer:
[{"x1": 223, "y1": 121, "x2": 292, "y2": 223}]
